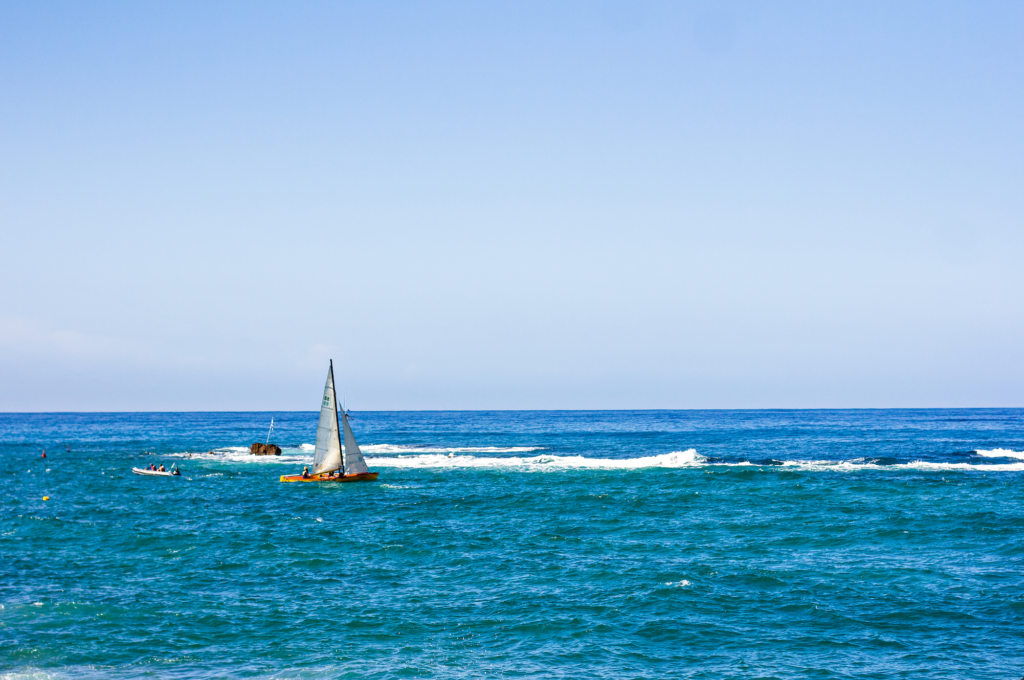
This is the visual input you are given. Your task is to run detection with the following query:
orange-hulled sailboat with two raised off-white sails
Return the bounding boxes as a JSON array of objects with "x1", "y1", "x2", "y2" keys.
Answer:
[{"x1": 281, "y1": 360, "x2": 380, "y2": 481}]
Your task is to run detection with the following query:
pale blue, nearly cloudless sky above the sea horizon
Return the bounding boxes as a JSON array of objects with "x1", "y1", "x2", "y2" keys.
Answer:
[{"x1": 0, "y1": 0, "x2": 1024, "y2": 412}]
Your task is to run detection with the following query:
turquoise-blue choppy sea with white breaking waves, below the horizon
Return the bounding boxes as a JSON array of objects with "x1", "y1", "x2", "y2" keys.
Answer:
[{"x1": 0, "y1": 410, "x2": 1024, "y2": 679}]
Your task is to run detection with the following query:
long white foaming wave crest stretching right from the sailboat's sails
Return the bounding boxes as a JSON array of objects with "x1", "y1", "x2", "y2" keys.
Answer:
[{"x1": 367, "y1": 449, "x2": 707, "y2": 470}]
